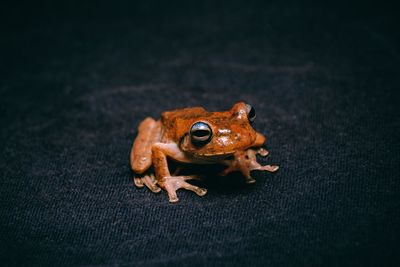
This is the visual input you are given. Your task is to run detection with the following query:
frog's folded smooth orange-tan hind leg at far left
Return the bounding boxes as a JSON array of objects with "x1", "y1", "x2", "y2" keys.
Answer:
[{"x1": 130, "y1": 117, "x2": 161, "y2": 174}]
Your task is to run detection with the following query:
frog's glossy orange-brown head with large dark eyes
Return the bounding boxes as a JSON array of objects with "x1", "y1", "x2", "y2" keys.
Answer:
[{"x1": 180, "y1": 102, "x2": 257, "y2": 161}]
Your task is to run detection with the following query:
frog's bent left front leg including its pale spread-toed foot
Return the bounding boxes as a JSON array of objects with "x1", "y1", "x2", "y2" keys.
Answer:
[{"x1": 152, "y1": 143, "x2": 207, "y2": 202}]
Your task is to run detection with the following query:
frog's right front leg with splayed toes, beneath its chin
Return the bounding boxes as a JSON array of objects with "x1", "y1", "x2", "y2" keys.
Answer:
[{"x1": 220, "y1": 148, "x2": 279, "y2": 183}]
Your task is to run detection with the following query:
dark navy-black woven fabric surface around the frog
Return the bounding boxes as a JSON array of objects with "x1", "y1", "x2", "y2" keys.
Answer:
[{"x1": 0, "y1": 1, "x2": 400, "y2": 266}]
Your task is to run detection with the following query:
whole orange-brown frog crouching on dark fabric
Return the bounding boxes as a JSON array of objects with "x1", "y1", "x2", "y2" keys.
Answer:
[{"x1": 130, "y1": 101, "x2": 279, "y2": 202}]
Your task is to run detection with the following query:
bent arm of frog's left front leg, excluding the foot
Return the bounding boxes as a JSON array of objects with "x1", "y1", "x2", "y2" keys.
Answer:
[{"x1": 152, "y1": 143, "x2": 190, "y2": 178}]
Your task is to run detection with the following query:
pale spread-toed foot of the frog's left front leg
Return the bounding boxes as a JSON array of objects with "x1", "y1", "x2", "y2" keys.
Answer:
[{"x1": 158, "y1": 175, "x2": 207, "y2": 202}]
